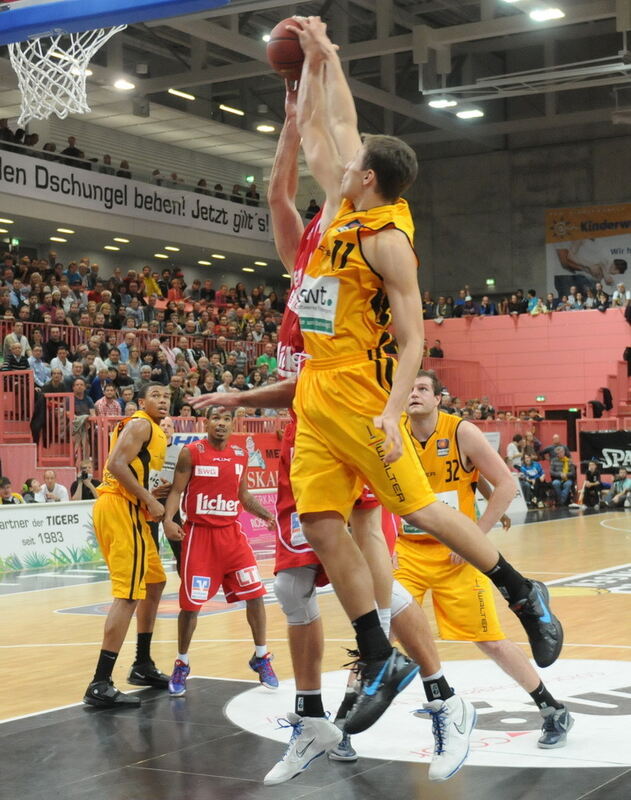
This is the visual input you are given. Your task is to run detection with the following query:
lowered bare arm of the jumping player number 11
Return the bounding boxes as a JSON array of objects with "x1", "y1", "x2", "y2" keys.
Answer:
[{"x1": 370, "y1": 229, "x2": 423, "y2": 463}]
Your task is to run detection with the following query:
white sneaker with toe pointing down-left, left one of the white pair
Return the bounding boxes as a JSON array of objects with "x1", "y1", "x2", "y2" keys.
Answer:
[{"x1": 263, "y1": 711, "x2": 344, "y2": 786}]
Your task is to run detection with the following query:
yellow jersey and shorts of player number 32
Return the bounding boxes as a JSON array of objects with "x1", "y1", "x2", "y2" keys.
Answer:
[{"x1": 394, "y1": 411, "x2": 505, "y2": 642}]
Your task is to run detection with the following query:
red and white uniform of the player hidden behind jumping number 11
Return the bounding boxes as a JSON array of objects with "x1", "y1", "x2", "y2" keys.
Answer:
[{"x1": 274, "y1": 212, "x2": 396, "y2": 586}]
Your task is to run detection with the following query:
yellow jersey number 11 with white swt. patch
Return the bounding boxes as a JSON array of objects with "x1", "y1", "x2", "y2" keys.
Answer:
[{"x1": 290, "y1": 199, "x2": 414, "y2": 359}]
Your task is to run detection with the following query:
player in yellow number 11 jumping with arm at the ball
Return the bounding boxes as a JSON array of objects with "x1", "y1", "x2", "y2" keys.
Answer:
[{"x1": 291, "y1": 17, "x2": 562, "y2": 733}]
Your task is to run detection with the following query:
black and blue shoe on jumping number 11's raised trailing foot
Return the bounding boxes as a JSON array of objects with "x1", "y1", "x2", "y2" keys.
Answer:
[{"x1": 511, "y1": 581, "x2": 563, "y2": 667}]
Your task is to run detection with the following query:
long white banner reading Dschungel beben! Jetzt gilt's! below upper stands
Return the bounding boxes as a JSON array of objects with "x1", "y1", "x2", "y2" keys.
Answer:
[{"x1": 0, "y1": 150, "x2": 271, "y2": 241}]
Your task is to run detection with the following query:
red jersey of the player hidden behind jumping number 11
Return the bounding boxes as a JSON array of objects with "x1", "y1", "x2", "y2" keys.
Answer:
[{"x1": 276, "y1": 211, "x2": 322, "y2": 380}]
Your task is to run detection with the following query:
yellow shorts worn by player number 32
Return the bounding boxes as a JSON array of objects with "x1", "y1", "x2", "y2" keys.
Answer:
[{"x1": 394, "y1": 537, "x2": 506, "y2": 642}]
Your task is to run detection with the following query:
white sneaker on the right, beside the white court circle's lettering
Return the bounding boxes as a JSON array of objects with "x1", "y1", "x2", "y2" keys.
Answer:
[{"x1": 416, "y1": 695, "x2": 477, "y2": 781}]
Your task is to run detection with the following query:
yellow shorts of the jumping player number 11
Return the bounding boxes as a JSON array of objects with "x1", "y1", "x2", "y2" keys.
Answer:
[{"x1": 291, "y1": 355, "x2": 436, "y2": 520}]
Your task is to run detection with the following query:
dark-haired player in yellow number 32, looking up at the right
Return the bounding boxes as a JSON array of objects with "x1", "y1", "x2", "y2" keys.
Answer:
[{"x1": 394, "y1": 370, "x2": 573, "y2": 749}]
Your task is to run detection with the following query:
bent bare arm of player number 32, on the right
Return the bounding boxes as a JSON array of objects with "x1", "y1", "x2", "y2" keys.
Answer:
[{"x1": 456, "y1": 422, "x2": 515, "y2": 533}]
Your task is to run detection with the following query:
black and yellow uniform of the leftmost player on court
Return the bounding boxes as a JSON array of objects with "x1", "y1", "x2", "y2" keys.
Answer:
[{"x1": 94, "y1": 411, "x2": 167, "y2": 600}]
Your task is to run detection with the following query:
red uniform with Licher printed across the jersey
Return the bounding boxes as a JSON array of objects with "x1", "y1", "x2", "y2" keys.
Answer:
[{"x1": 180, "y1": 439, "x2": 266, "y2": 611}]
